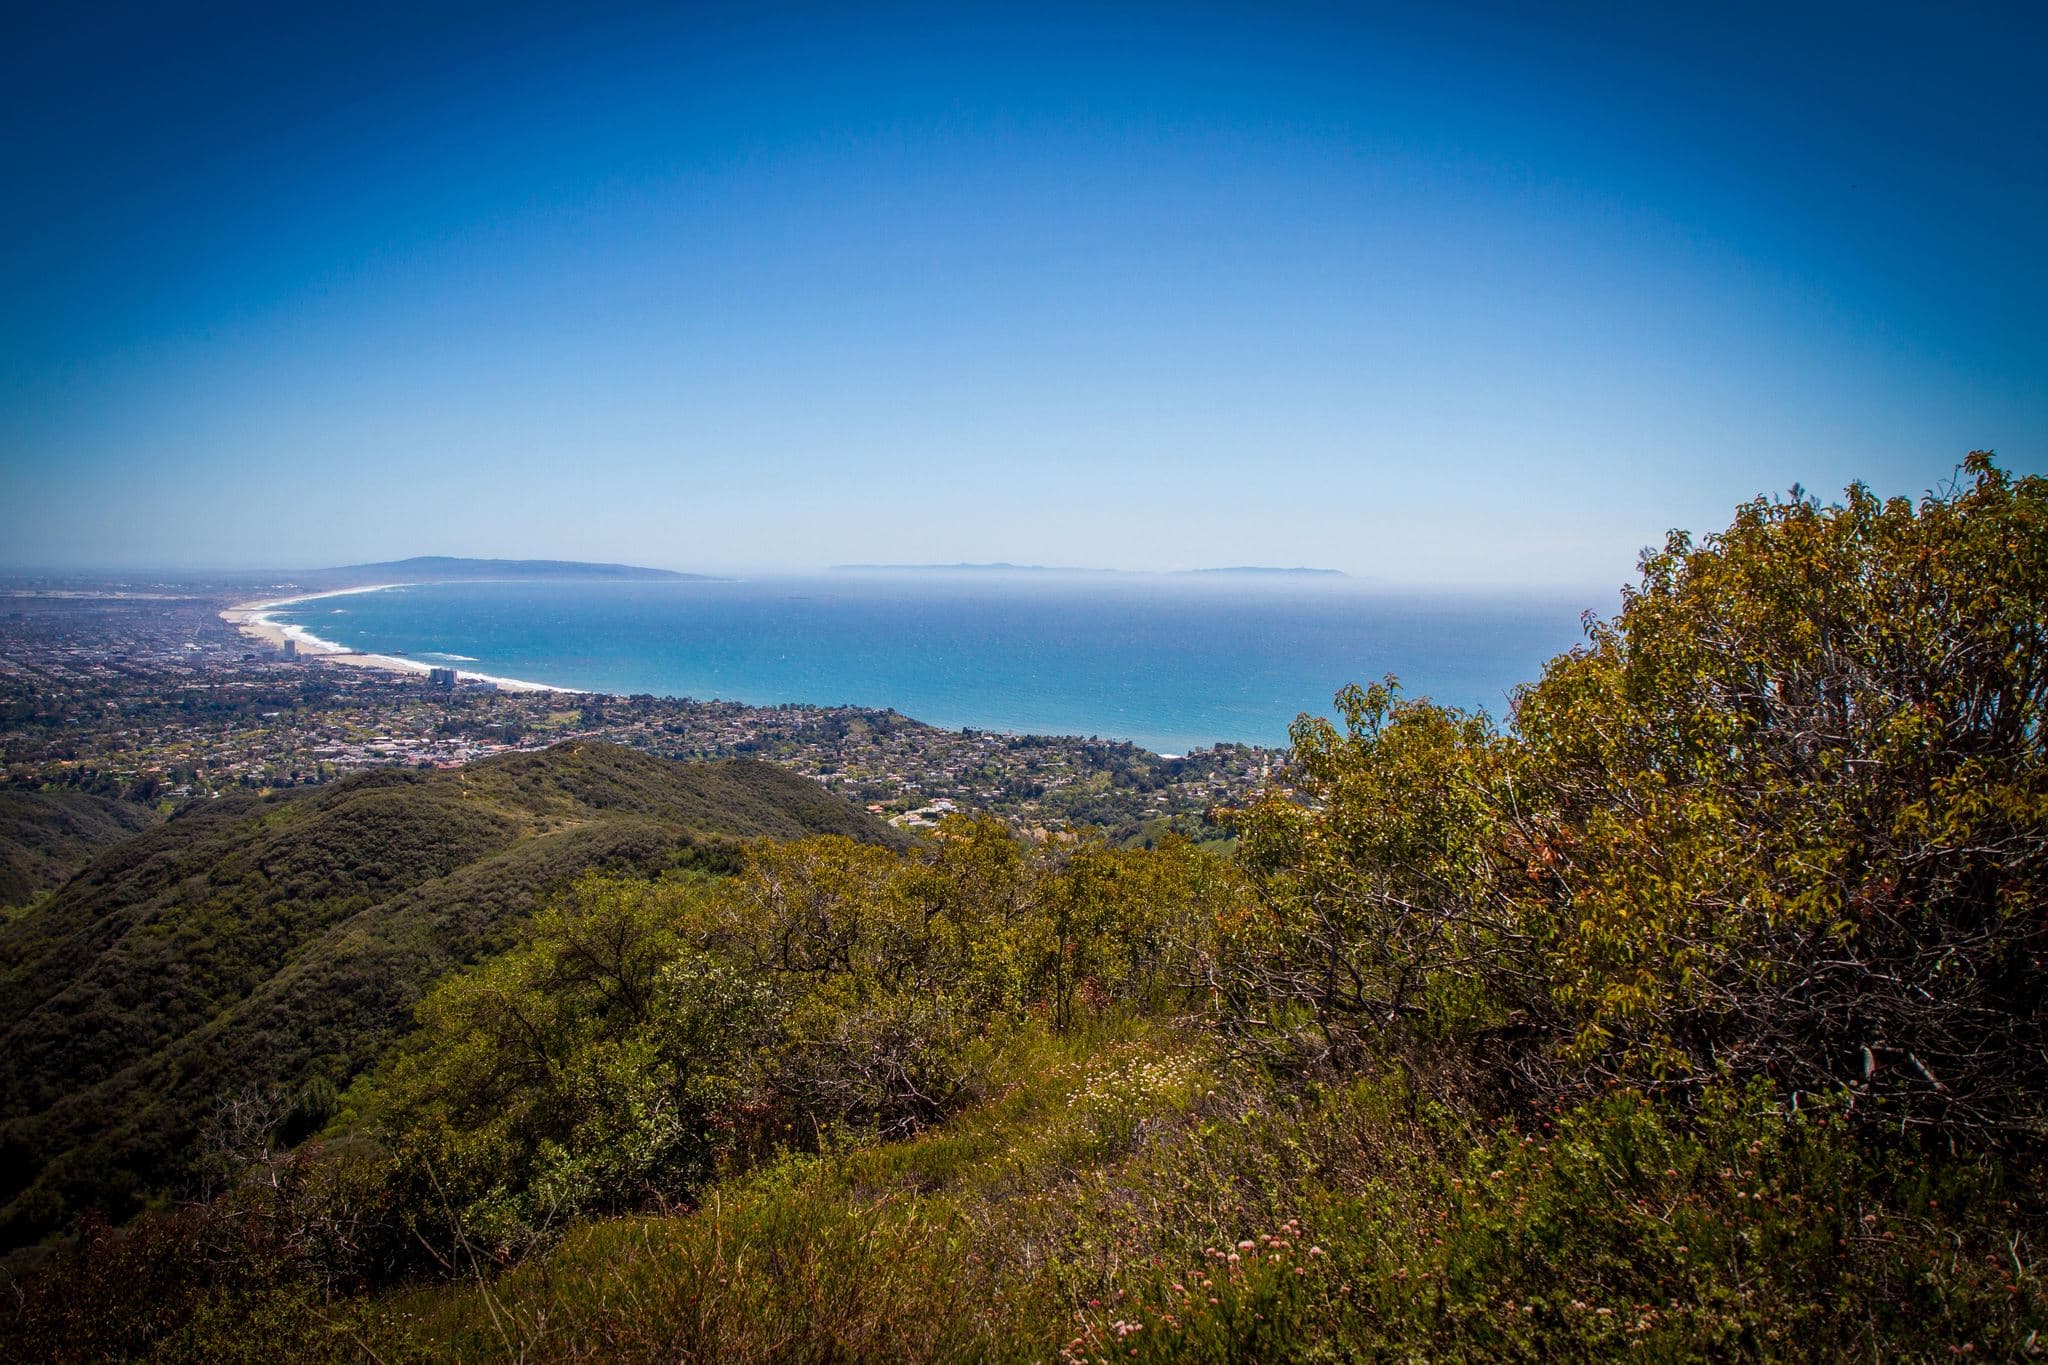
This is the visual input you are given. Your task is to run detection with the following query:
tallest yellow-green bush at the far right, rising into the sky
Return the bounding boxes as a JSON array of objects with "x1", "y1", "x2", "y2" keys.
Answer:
[{"x1": 1513, "y1": 454, "x2": 2048, "y2": 1134}]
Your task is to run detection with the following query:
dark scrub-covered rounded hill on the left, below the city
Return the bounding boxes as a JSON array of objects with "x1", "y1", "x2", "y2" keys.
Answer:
[{"x1": 0, "y1": 743, "x2": 901, "y2": 1244}]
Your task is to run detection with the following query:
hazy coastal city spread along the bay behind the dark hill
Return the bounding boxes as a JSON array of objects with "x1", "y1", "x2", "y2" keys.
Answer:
[{"x1": 0, "y1": 583, "x2": 1286, "y2": 841}]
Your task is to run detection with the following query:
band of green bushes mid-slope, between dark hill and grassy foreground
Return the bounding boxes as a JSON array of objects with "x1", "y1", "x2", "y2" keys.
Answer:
[{"x1": 336, "y1": 821, "x2": 1231, "y2": 1261}]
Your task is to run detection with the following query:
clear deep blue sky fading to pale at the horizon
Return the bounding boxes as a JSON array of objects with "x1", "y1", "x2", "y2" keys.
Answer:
[{"x1": 0, "y1": 4, "x2": 2048, "y2": 585}]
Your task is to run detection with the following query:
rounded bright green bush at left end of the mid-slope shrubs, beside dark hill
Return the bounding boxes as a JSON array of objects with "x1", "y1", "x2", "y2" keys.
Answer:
[{"x1": 344, "y1": 878, "x2": 774, "y2": 1254}]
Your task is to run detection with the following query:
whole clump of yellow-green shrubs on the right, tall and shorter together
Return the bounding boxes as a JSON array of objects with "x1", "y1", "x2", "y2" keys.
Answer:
[{"x1": 1217, "y1": 456, "x2": 2048, "y2": 1138}]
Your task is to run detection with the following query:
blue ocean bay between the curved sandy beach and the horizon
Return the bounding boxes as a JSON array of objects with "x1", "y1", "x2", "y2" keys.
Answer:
[{"x1": 272, "y1": 573, "x2": 1612, "y2": 753}]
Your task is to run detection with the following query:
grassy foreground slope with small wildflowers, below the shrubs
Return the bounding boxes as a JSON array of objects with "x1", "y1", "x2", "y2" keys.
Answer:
[{"x1": 327, "y1": 1023, "x2": 2048, "y2": 1361}]
